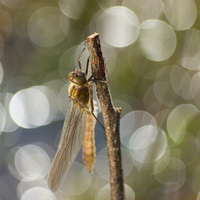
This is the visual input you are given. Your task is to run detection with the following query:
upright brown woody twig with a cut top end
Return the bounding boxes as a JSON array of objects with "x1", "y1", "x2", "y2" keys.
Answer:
[{"x1": 87, "y1": 33, "x2": 125, "y2": 200}]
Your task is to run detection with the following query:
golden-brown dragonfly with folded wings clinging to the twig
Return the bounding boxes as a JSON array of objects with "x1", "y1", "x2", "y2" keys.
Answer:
[{"x1": 47, "y1": 44, "x2": 107, "y2": 192}]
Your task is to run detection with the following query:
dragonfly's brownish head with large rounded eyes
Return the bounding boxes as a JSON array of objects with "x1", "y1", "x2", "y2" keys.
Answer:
[{"x1": 68, "y1": 69, "x2": 87, "y2": 85}]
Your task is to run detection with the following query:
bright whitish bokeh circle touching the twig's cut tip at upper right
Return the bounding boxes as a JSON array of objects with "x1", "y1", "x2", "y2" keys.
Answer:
[{"x1": 97, "y1": 6, "x2": 139, "y2": 47}]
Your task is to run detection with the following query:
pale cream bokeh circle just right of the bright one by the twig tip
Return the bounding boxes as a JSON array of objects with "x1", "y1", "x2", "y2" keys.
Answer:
[{"x1": 139, "y1": 20, "x2": 176, "y2": 61}]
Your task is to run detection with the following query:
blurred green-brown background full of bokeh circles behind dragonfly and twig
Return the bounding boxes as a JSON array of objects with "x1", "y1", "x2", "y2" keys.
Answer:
[{"x1": 0, "y1": 0, "x2": 200, "y2": 200}]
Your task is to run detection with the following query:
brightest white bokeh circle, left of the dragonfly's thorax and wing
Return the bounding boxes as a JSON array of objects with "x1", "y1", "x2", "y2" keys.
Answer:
[{"x1": 9, "y1": 88, "x2": 49, "y2": 128}]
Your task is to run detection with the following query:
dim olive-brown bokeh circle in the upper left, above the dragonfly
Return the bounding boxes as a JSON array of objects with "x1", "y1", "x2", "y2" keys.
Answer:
[{"x1": 28, "y1": 7, "x2": 69, "y2": 47}]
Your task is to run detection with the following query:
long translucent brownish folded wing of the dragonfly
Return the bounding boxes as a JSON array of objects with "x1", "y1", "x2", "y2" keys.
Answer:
[{"x1": 47, "y1": 101, "x2": 85, "y2": 192}]
